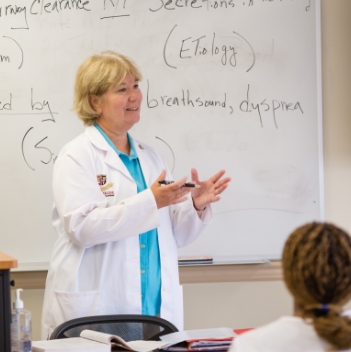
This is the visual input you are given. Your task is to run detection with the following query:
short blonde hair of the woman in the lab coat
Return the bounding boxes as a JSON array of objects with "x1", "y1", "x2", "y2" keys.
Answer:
[{"x1": 73, "y1": 51, "x2": 142, "y2": 126}]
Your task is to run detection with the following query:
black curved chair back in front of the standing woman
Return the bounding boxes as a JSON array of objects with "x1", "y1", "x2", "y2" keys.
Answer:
[{"x1": 50, "y1": 314, "x2": 178, "y2": 342}]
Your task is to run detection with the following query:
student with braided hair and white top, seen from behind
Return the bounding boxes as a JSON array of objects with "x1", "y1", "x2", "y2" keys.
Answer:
[{"x1": 230, "y1": 223, "x2": 351, "y2": 352}]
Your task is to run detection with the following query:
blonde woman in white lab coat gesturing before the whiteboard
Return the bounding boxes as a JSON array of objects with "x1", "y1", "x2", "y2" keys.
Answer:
[{"x1": 42, "y1": 52, "x2": 229, "y2": 338}]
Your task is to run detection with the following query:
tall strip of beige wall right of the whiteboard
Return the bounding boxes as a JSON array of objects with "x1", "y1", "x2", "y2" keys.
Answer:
[{"x1": 322, "y1": 0, "x2": 351, "y2": 232}]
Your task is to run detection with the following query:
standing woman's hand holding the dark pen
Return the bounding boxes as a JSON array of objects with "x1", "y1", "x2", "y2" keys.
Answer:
[{"x1": 150, "y1": 170, "x2": 191, "y2": 209}]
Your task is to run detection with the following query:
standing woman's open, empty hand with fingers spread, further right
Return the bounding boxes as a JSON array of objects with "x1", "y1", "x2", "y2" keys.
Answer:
[{"x1": 191, "y1": 169, "x2": 230, "y2": 211}]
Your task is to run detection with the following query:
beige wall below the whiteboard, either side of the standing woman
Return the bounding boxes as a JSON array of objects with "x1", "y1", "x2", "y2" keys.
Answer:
[{"x1": 12, "y1": 281, "x2": 292, "y2": 340}]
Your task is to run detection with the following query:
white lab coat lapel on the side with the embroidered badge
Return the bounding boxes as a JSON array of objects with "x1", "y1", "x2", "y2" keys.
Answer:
[{"x1": 85, "y1": 126, "x2": 134, "y2": 182}]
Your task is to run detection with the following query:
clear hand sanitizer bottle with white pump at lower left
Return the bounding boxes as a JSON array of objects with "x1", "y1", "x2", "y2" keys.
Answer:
[{"x1": 11, "y1": 288, "x2": 32, "y2": 352}]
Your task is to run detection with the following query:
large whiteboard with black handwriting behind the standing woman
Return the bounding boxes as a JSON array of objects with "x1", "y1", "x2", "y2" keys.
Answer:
[{"x1": 0, "y1": 0, "x2": 324, "y2": 269}]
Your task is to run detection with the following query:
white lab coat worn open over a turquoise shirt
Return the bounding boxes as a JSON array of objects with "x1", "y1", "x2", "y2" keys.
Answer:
[{"x1": 42, "y1": 126, "x2": 212, "y2": 339}]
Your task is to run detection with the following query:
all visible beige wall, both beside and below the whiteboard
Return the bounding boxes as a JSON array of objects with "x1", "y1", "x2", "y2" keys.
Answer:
[{"x1": 9, "y1": 0, "x2": 351, "y2": 340}]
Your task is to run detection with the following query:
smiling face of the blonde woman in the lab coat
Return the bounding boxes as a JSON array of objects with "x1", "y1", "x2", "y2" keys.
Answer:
[{"x1": 92, "y1": 75, "x2": 143, "y2": 132}]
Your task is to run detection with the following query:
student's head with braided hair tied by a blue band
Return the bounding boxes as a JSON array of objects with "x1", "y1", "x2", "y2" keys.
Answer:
[{"x1": 283, "y1": 223, "x2": 351, "y2": 349}]
